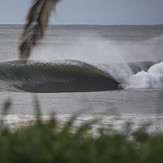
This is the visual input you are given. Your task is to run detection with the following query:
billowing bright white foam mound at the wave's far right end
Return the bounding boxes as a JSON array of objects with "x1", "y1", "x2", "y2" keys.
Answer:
[{"x1": 123, "y1": 62, "x2": 163, "y2": 89}]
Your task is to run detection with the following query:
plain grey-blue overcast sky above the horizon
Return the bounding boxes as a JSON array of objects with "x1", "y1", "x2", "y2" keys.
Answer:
[{"x1": 0, "y1": 0, "x2": 163, "y2": 25}]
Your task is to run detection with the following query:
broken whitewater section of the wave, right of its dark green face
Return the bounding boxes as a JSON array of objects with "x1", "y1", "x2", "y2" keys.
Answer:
[{"x1": 96, "y1": 62, "x2": 163, "y2": 89}]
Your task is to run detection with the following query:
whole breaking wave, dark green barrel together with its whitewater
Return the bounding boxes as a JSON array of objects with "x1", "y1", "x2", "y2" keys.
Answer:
[{"x1": 0, "y1": 60, "x2": 163, "y2": 93}]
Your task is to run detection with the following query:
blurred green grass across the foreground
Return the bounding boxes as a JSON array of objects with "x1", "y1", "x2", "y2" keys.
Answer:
[{"x1": 0, "y1": 98, "x2": 163, "y2": 163}]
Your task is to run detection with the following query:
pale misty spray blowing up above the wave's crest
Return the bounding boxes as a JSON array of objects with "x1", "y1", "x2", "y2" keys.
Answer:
[{"x1": 31, "y1": 33, "x2": 163, "y2": 64}]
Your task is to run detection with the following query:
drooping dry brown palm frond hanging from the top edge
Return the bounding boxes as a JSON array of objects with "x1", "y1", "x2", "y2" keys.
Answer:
[{"x1": 19, "y1": 0, "x2": 60, "y2": 62}]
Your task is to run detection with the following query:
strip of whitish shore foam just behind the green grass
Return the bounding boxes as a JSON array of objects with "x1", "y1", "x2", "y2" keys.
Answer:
[{"x1": 0, "y1": 114, "x2": 163, "y2": 134}]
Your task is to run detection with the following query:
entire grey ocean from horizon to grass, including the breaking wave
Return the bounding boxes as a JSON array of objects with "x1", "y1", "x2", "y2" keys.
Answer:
[{"x1": 0, "y1": 25, "x2": 163, "y2": 130}]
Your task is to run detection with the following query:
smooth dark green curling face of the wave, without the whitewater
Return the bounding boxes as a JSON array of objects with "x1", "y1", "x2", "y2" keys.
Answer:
[{"x1": 0, "y1": 61, "x2": 119, "y2": 93}]
